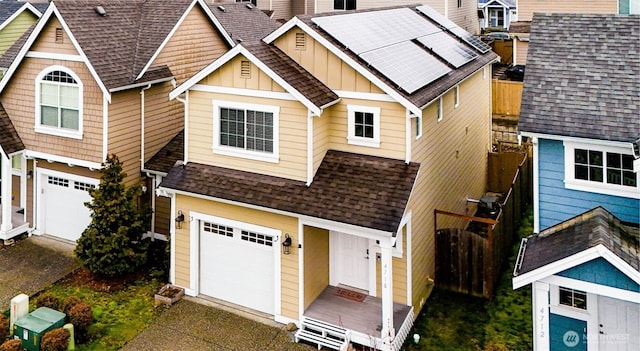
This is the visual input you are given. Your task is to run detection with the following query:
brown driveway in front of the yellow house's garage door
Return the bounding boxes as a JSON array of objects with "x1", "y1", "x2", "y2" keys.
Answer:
[{"x1": 120, "y1": 297, "x2": 317, "y2": 351}]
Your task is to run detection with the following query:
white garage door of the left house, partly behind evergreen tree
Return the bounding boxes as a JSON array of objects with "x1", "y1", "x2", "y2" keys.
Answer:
[{"x1": 41, "y1": 174, "x2": 99, "y2": 241}]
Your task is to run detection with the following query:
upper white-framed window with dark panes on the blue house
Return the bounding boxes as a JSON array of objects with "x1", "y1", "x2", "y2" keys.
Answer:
[{"x1": 564, "y1": 142, "x2": 640, "y2": 198}]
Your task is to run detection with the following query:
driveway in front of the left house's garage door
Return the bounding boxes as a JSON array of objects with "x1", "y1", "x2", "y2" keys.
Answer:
[{"x1": 0, "y1": 235, "x2": 80, "y2": 312}]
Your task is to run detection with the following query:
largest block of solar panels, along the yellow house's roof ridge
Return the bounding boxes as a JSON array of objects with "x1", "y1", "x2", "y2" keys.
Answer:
[{"x1": 311, "y1": 8, "x2": 440, "y2": 55}]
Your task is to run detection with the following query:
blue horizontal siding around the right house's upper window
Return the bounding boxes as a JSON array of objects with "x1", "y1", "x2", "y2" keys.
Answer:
[{"x1": 538, "y1": 139, "x2": 640, "y2": 230}]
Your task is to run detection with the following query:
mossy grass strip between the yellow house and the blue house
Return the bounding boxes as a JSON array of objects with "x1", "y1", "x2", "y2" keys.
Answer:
[{"x1": 403, "y1": 213, "x2": 533, "y2": 351}]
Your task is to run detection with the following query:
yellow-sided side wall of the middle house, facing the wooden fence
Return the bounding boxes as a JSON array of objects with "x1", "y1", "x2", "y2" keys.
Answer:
[{"x1": 408, "y1": 70, "x2": 491, "y2": 313}]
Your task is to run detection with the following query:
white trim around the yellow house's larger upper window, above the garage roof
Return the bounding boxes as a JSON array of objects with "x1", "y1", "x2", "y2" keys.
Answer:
[{"x1": 212, "y1": 100, "x2": 280, "y2": 163}]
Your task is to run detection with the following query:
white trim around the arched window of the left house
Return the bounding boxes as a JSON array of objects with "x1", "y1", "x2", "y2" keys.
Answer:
[{"x1": 34, "y1": 65, "x2": 84, "y2": 139}]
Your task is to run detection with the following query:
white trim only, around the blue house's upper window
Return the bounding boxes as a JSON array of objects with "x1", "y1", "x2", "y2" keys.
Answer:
[{"x1": 564, "y1": 141, "x2": 640, "y2": 199}]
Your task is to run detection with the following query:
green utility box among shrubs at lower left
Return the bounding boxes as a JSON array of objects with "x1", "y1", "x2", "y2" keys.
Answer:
[{"x1": 13, "y1": 307, "x2": 66, "y2": 351}]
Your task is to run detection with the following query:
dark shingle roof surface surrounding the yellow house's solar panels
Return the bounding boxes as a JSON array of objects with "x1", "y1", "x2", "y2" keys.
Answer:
[{"x1": 298, "y1": 5, "x2": 498, "y2": 108}]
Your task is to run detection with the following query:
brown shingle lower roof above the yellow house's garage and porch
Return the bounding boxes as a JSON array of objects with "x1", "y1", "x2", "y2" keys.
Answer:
[{"x1": 160, "y1": 150, "x2": 419, "y2": 233}]
